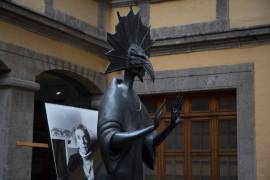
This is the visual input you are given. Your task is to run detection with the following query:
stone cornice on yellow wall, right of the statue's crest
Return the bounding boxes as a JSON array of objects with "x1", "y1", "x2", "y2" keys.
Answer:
[{"x1": 151, "y1": 25, "x2": 270, "y2": 56}]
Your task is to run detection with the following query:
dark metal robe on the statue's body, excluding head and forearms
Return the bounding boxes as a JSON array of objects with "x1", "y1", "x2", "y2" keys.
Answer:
[{"x1": 97, "y1": 79, "x2": 154, "y2": 180}]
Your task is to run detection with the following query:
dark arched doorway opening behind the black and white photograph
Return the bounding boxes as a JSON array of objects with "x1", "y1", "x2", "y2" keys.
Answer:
[{"x1": 32, "y1": 70, "x2": 102, "y2": 180}]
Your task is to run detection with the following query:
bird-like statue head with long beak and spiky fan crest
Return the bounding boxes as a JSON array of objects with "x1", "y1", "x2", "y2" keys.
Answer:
[{"x1": 105, "y1": 9, "x2": 155, "y2": 81}]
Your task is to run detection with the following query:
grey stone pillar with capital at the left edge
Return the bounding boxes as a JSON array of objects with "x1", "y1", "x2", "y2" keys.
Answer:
[{"x1": 0, "y1": 77, "x2": 39, "y2": 180}]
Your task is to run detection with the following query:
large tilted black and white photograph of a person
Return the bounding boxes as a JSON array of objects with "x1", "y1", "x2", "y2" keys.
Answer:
[{"x1": 45, "y1": 103, "x2": 98, "y2": 180}]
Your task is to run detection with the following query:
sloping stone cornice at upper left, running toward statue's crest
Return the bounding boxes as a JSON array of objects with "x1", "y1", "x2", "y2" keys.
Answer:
[{"x1": 0, "y1": 1, "x2": 109, "y2": 57}]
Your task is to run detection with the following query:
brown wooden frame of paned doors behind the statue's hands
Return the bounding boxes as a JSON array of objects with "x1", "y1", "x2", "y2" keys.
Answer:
[{"x1": 143, "y1": 91, "x2": 237, "y2": 180}]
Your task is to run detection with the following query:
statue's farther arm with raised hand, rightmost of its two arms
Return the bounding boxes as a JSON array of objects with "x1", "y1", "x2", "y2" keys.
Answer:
[{"x1": 153, "y1": 96, "x2": 183, "y2": 146}]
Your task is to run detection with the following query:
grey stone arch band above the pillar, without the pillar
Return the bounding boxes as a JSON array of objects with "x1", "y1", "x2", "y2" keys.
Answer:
[{"x1": 0, "y1": 41, "x2": 107, "y2": 94}]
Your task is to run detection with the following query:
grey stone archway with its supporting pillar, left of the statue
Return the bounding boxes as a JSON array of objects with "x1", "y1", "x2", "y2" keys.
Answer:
[{"x1": 0, "y1": 42, "x2": 107, "y2": 179}]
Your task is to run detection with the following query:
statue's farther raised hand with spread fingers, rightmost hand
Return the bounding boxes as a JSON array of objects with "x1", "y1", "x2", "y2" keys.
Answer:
[{"x1": 170, "y1": 96, "x2": 184, "y2": 128}]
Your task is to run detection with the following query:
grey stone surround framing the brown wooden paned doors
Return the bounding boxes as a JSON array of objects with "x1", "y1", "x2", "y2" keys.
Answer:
[{"x1": 134, "y1": 64, "x2": 256, "y2": 180}]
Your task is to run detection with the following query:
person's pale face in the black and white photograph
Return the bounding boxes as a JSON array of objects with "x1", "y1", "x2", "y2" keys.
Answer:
[{"x1": 75, "y1": 129, "x2": 90, "y2": 155}]
